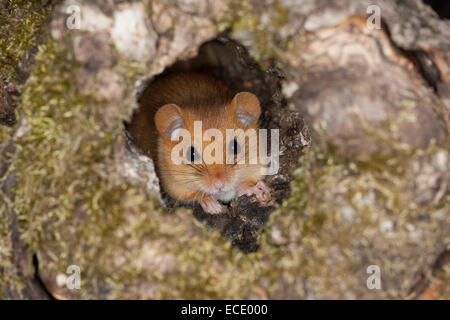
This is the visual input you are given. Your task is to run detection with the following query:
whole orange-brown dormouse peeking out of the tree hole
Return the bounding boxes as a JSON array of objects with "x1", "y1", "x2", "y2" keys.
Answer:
[{"x1": 130, "y1": 72, "x2": 270, "y2": 214}]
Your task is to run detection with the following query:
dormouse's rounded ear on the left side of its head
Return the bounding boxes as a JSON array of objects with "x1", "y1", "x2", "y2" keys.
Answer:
[{"x1": 155, "y1": 103, "x2": 184, "y2": 138}]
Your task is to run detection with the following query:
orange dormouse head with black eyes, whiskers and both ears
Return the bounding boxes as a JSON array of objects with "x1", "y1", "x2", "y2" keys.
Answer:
[{"x1": 155, "y1": 92, "x2": 261, "y2": 198}]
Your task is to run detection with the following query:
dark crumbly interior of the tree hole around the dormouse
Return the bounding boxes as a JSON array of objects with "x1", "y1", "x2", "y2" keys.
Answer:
[{"x1": 126, "y1": 35, "x2": 309, "y2": 252}]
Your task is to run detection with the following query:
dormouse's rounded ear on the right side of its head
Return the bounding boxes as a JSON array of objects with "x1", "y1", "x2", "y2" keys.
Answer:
[{"x1": 231, "y1": 92, "x2": 261, "y2": 127}]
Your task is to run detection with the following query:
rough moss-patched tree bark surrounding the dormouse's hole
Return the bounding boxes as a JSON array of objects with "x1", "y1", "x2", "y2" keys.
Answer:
[{"x1": 0, "y1": 0, "x2": 450, "y2": 299}]
